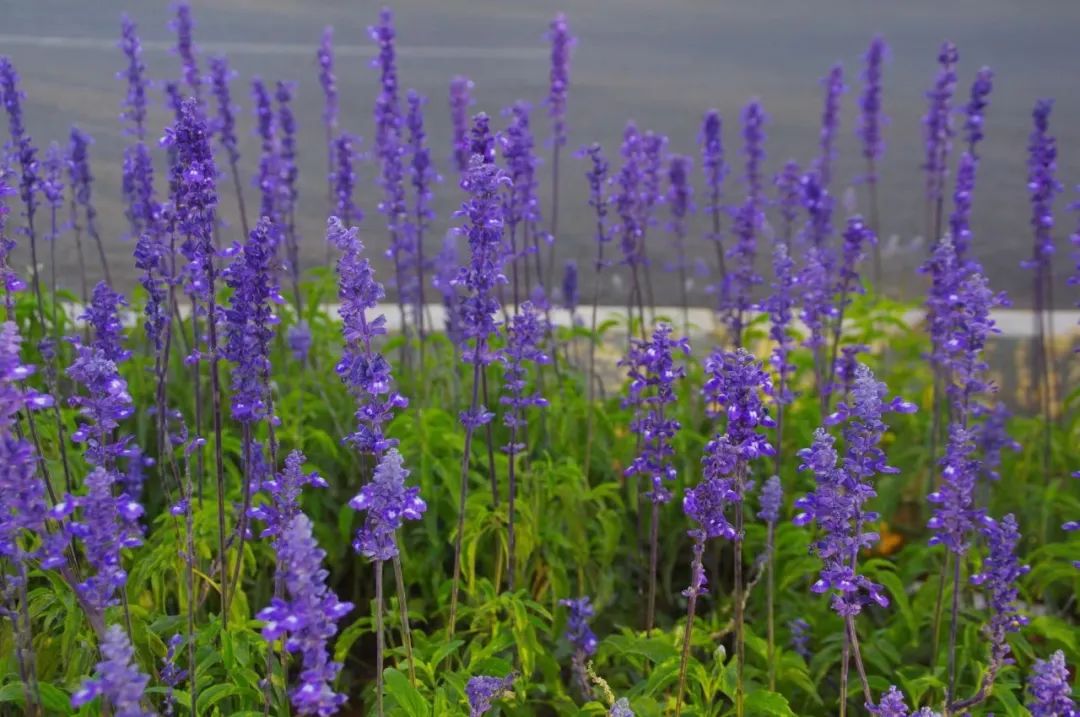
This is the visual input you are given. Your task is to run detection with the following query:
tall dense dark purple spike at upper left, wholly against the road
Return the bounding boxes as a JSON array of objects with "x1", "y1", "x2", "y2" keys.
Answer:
[{"x1": 162, "y1": 98, "x2": 217, "y2": 301}]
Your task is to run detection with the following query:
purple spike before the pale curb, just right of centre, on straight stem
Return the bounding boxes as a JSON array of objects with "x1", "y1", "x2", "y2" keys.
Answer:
[{"x1": 620, "y1": 323, "x2": 690, "y2": 503}]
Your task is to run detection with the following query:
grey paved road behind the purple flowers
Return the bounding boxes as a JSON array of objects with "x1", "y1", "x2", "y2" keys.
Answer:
[{"x1": 0, "y1": 0, "x2": 1080, "y2": 306}]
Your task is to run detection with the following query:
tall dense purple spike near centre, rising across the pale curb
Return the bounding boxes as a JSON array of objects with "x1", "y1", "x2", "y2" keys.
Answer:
[{"x1": 455, "y1": 137, "x2": 509, "y2": 380}]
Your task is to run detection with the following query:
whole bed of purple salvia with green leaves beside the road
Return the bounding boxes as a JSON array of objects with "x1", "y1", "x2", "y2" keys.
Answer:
[{"x1": 0, "y1": 2, "x2": 1080, "y2": 717}]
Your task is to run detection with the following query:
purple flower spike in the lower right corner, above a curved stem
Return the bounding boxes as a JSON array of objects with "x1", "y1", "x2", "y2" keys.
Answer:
[{"x1": 971, "y1": 513, "x2": 1029, "y2": 672}]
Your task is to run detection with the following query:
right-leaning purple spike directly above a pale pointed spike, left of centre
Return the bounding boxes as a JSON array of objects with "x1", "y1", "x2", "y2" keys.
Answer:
[{"x1": 326, "y1": 217, "x2": 408, "y2": 456}]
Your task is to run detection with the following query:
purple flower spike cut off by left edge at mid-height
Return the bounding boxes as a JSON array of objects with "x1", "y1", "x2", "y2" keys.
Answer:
[{"x1": 0, "y1": 321, "x2": 66, "y2": 574}]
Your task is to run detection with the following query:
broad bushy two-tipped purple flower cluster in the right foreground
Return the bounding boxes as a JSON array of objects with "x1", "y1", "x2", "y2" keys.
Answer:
[{"x1": 795, "y1": 365, "x2": 915, "y2": 617}]
